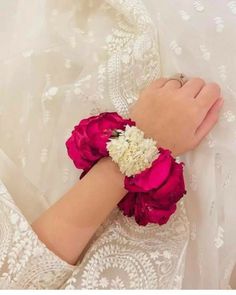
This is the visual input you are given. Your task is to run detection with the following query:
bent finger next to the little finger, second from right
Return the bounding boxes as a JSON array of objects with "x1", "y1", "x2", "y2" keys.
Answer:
[{"x1": 196, "y1": 83, "x2": 220, "y2": 115}]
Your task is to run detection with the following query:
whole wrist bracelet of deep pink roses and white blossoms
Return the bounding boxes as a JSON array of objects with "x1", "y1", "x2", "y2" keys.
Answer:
[{"x1": 66, "y1": 112, "x2": 186, "y2": 225}]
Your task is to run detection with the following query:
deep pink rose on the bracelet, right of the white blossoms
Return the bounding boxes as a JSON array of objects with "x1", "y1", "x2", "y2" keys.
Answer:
[{"x1": 118, "y1": 149, "x2": 186, "y2": 225}]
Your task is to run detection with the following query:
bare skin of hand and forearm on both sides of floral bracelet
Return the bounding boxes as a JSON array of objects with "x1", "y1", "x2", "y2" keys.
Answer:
[{"x1": 32, "y1": 78, "x2": 223, "y2": 265}]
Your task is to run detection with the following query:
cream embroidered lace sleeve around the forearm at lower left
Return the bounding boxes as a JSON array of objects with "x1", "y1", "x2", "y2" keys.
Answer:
[{"x1": 0, "y1": 181, "x2": 74, "y2": 289}]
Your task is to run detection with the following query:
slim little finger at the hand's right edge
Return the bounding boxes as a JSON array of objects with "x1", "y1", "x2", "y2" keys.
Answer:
[{"x1": 195, "y1": 98, "x2": 224, "y2": 142}]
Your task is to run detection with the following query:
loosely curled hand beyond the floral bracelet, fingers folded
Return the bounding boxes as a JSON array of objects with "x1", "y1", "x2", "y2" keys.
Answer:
[{"x1": 130, "y1": 78, "x2": 223, "y2": 156}]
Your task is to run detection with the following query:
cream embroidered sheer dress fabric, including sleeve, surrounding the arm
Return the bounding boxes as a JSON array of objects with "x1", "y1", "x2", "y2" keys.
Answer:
[{"x1": 0, "y1": 0, "x2": 236, "y2": 289}]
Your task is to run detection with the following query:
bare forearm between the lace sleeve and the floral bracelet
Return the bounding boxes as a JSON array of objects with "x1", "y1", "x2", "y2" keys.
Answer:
[{"x1": 32, "y1": 158, "x2": 126, "y2": 264}]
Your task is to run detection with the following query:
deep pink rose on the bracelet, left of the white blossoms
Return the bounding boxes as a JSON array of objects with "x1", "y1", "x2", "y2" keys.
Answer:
[{"x1": 66, "y1": 112, "x2": 135, "y2": 172}]
